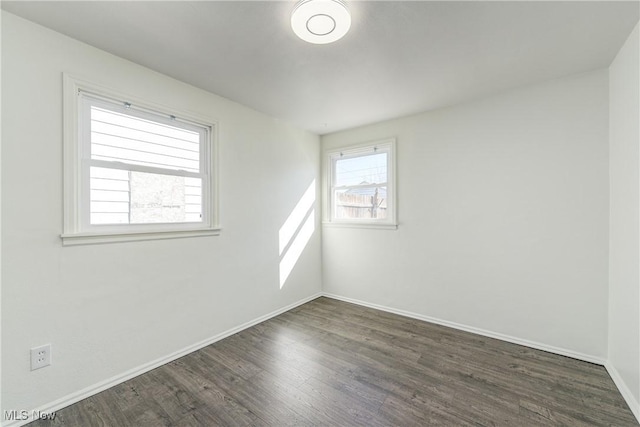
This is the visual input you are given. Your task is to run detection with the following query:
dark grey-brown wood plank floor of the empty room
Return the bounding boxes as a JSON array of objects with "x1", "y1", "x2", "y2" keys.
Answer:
[{"x1": 31, "y1": 298, "x2": 638, "y2": 427}]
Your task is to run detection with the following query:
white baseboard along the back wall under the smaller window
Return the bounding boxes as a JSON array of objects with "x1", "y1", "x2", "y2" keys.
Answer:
[{"x1": 322, "y1": 292, "x2": 605, "y2": 365}]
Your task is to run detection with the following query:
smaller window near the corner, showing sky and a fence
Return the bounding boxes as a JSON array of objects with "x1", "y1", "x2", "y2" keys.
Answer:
[{"x1": 327, "y1": 140, "x2": 396, "y2": 228}]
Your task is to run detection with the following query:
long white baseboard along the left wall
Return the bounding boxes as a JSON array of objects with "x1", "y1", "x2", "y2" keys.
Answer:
[{"x1": 2, "y1": 293, "x2": 322, "y2": 427}]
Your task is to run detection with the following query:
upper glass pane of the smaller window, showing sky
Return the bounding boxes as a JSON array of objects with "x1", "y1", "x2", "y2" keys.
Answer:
[{"x1": 335, "y1": 153, "x2": 387, "y2": 187}]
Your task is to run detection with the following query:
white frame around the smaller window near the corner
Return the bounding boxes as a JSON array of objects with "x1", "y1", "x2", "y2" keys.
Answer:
[{"x1": 323, "y1": 138, "x2": 398, "y2": 230}]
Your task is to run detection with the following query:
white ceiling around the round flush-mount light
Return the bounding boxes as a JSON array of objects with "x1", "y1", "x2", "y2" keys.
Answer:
[{"x1": 2, "y1": 1, "x2": 639, "y2": 134}]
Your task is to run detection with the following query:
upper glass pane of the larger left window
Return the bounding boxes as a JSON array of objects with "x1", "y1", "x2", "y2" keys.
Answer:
[{"x1": 91, "y1": 106, "x2": 200, "y2": 172}]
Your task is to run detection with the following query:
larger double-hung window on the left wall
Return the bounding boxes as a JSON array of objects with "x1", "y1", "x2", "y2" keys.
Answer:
[{"x1": 63, "y1": 78, "x2": 217, "y2": 244}]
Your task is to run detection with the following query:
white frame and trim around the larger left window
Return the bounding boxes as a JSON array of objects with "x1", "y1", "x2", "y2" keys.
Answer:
[{"x1": 61, "y1": 73, "x2": 220, "y2": 246}]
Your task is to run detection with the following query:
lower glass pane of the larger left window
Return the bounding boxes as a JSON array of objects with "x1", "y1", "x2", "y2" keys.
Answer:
[{"x1": 89, "y1": 167, "x2": 202, "y2": 224}]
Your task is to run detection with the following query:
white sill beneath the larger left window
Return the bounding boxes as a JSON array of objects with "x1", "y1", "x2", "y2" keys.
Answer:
[{"x1": 60, "y1": 228, "x2": 220, "y2": 246}]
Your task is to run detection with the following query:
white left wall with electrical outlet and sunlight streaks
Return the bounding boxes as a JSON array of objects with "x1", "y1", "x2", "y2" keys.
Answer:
[{"x1": 2, "y1": 13, "x2": 321, "y2": 422}]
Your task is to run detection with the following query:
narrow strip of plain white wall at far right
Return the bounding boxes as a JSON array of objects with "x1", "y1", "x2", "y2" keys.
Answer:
[{"x1": 608, "y1": 20, "x2": 640, "y2": 419}]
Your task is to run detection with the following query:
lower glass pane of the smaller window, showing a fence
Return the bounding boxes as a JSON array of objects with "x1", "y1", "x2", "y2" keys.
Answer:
[{"x1": 334, "y1": 186, "x2": 387, "y2": 219}]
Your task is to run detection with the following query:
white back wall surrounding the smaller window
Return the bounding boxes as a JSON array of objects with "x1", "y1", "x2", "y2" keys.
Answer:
[{"x1": 322, "y1": 70, "x2": 609, "y2": 361}]
